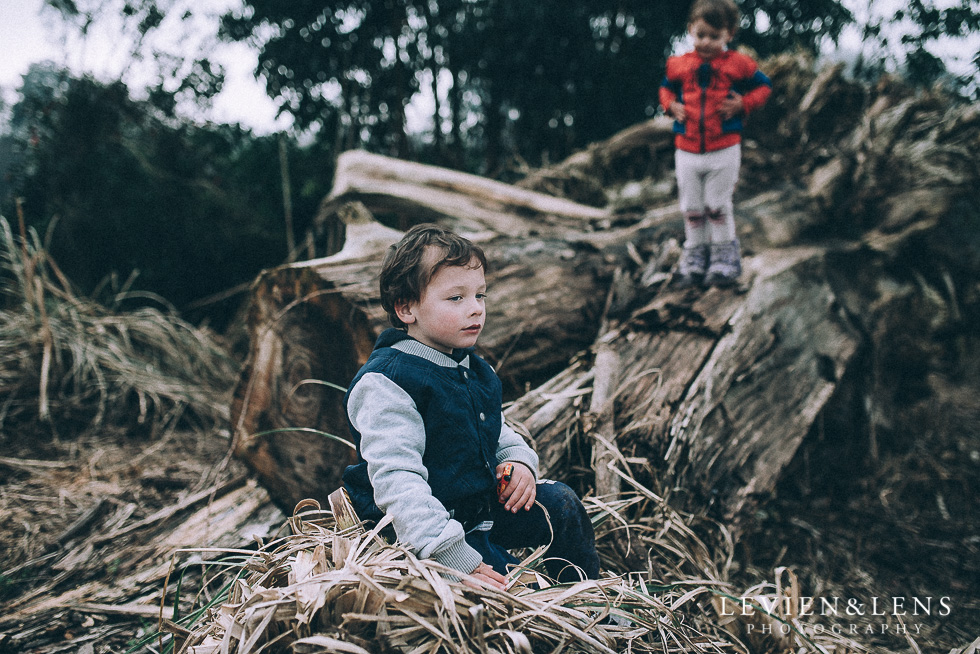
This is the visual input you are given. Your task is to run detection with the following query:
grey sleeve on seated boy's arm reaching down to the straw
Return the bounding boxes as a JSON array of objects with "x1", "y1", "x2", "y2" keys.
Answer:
[{"x1": 347, "y1": 373, "x2": 482, "y2": 573}]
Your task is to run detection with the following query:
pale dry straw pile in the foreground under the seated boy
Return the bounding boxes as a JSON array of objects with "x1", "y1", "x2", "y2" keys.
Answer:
[{"x1": 161, "y1": 493, "x2": 860, "y2": 654}]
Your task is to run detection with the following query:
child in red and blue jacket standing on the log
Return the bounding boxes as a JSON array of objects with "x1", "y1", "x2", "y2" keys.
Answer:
[{"x1": 660, "y1": 0, "x2": 772, "y2": 286}]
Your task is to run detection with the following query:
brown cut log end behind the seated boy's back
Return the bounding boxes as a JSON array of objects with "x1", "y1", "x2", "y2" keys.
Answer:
[{"x1": 232, "y1": 268, "x2": 374, "y2": 512}]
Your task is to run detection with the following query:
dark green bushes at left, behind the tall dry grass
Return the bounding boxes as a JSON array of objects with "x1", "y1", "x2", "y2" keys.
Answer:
[{"x1": 0, "y1": 66, "x2": 332, "y2": 324}]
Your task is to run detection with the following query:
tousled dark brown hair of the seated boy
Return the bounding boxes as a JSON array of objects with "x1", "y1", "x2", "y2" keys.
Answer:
[{"x1": 381, "y1": 223, "x2": 487, "y2": 329}]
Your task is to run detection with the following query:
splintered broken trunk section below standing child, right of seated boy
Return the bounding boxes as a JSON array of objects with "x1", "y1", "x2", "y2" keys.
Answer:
[{"x1": 506, "y1": 250, "x2": 860, "y2": 529}]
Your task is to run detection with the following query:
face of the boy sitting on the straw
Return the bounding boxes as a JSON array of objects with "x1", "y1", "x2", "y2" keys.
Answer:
[{"x1": 395, "y1": 253, "x2": 487, "y2": 354}]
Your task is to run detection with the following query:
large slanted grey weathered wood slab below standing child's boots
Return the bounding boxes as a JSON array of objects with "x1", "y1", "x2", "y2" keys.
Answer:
[{"x1": 619, "y1": 250, "x2": 861, "y2": 528}]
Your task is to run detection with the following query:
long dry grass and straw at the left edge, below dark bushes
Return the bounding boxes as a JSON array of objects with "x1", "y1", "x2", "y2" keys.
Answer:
[{"x1": 0, "y1": 217, "x2": 249, "y2": 608}]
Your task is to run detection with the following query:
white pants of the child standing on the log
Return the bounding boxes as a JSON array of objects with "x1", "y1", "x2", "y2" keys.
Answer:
[{"x1": 674, "y1": 144, "x2": 742, "y2": 246}]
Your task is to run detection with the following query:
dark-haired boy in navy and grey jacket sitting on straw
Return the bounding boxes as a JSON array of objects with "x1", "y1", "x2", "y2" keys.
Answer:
[{"x1": 344, "y1": 225, "x2": 599, "y2": 588}]
